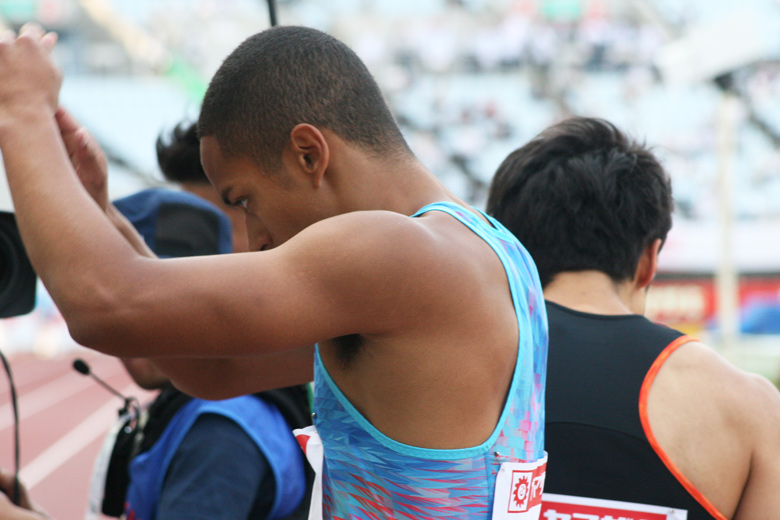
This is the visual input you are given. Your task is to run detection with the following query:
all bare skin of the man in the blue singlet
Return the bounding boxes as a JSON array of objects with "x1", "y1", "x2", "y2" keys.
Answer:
[{"x1": 0, "y1": 30, "x2": 518, "y2": 456}]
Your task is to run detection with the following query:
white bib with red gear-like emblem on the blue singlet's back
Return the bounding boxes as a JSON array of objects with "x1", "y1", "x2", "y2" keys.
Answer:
[{"x1": 493, "y1": 452, "x2": 547, "y2": 520}]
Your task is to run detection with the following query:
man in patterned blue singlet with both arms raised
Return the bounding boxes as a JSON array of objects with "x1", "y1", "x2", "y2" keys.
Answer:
[{"x1": 0, "y1": 23, "x2": 547, "y2": 519}]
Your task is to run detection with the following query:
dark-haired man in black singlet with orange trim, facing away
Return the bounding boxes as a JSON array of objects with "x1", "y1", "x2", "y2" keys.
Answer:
[{"x1": 488, "y1": 118, "x2": 780, "y2": 520}]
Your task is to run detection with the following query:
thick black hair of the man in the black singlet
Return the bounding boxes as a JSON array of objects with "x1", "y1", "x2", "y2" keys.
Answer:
[{"x1": 487, "y1": 117, "x2": 673, "y2": 287}]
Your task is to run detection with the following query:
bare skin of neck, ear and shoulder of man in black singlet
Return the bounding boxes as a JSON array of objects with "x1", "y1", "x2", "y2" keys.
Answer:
[{"x1": 544, "y1": 246, "x2": 780, "y2": 520}]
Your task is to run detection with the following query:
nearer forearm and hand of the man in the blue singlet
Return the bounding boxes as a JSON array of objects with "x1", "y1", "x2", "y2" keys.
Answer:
[{"x1": 0, "y1": 27, "x2": 149, "y2": 330}]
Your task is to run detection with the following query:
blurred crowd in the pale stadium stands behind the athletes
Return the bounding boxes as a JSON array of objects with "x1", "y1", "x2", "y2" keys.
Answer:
[{"x1": 0, "y1": 0, "x2": 780, "y2": 354}]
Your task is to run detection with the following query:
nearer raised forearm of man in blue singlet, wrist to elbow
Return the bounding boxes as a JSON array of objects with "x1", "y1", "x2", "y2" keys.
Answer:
[{"x1": 0, "y1": 108, "x2": 140, "y2": 324}]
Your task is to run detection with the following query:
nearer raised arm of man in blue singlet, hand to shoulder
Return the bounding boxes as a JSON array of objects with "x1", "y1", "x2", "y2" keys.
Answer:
[{"x1": 0, "y1": 26, "x2": 444, "y2": 374}]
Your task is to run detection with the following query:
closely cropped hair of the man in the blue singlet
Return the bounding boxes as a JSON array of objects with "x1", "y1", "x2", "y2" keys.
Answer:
[{"x1": 198, "y1": 26, "x2": 411, "y2": 170}]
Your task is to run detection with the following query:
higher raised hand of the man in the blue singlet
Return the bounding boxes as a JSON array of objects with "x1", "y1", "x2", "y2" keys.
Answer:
[{"x1": 0, "y1": 24, "x2": 62, "y2": 123}]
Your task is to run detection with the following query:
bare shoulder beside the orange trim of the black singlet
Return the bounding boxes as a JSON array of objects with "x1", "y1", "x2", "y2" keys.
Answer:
[{"x1": 648, "y1": 342, "x2": 780, "y2": 519}]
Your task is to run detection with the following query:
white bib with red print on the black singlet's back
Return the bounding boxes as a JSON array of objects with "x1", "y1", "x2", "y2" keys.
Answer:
[{"x1": 541, "y1": 493, "x2": 688, "y2": 520}]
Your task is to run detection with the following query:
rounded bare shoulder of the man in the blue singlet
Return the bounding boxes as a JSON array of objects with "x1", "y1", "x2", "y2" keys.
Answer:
[{"x1": 269, "y1": 211, "x2": 457, "y2": 334}]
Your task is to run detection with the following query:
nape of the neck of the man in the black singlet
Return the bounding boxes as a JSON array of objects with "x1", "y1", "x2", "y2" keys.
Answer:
[{"x1": 544, "y1": 271, "x2": 641, "y2": 315}]
